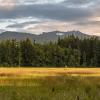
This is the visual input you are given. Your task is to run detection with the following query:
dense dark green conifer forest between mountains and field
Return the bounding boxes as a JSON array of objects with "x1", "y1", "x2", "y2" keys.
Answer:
[{"x1": 0, "y1": 35, "x2": 100, "y2": 67}]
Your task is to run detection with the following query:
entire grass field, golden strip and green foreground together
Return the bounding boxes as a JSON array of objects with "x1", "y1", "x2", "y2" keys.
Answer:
[{"x1": 0, "y1": 68, "x2": 100, "y2": 100}]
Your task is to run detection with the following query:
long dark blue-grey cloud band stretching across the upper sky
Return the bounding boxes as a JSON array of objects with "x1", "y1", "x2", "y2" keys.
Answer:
[{"x1": 0, "y1": 4, "x2": 92, "y2": 21}]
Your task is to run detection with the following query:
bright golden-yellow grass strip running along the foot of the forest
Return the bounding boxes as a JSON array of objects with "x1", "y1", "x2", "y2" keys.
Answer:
[{"x1": 0, "y1": 68, "x2": 100, "y2": 78}]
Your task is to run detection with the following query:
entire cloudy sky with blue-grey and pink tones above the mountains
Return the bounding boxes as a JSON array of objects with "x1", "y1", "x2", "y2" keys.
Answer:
[{"x1": 0, "y1": 0, "x2": 100, "y2": 35}]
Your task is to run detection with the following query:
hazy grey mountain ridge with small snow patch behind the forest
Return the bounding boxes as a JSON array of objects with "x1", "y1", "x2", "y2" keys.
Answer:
[{"x1": 0, "y1": 31, "x2": 96, "y2": 43}]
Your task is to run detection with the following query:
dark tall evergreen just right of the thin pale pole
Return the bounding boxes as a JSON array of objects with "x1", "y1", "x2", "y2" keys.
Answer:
[{"x1": 19, "y1": 39, "x2": 34, "y2": 66}]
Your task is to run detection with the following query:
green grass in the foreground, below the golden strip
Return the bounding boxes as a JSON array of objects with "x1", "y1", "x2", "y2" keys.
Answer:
[{"x1": 0, "y1": 76, "x2": 100, "y2": 100}]
